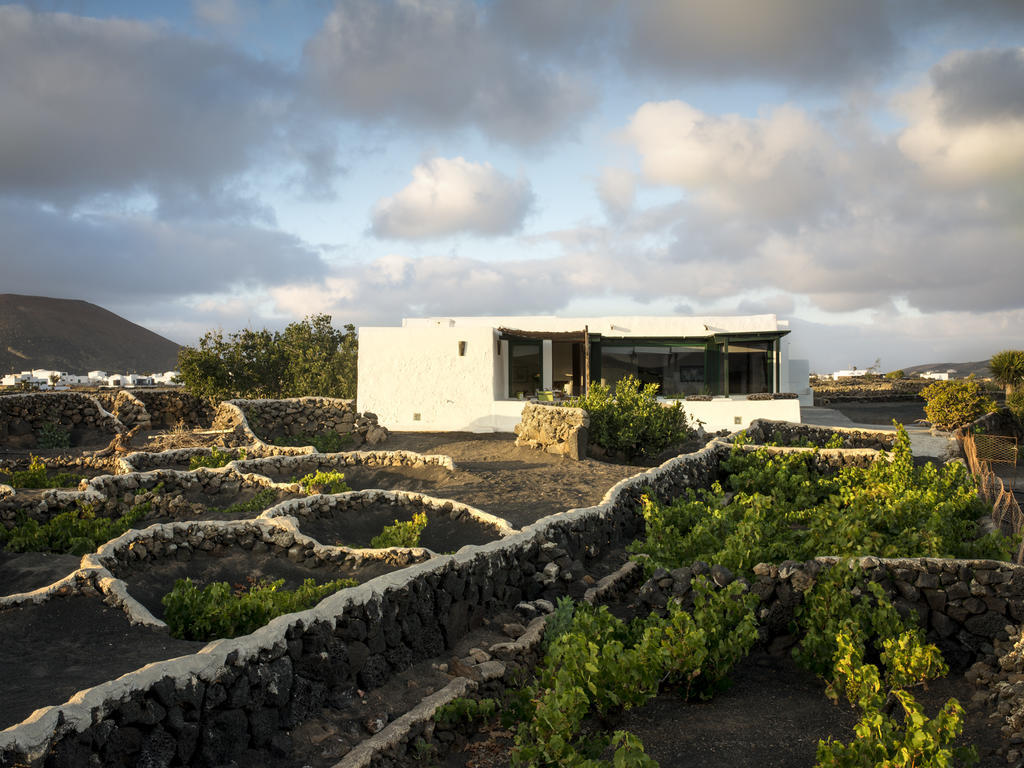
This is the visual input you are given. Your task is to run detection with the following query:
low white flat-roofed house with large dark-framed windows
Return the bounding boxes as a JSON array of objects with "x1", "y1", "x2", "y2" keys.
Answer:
[{"x1": 357, "y1": 314, "x2": 812, "y2": 432}]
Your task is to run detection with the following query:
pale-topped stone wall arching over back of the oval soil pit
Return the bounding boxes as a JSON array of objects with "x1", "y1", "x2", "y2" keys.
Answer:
[{"x1": 258, "y1": 487, "x2": 516, "y2": 538}]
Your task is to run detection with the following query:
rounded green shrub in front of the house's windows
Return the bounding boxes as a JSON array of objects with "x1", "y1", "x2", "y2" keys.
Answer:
[{"x1": 567, "y1": 376, "x2": 691, "y2": 460}]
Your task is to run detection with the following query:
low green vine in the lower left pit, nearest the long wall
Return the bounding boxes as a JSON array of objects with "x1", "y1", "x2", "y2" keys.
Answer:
[{"x1": 161, "y1": 579, "x2": 356, "y2": 640}]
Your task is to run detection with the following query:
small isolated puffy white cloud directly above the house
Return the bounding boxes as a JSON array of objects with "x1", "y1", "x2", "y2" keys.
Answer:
[{"x1": 373, "y1": 158, "x2": 534, "y2": 240}]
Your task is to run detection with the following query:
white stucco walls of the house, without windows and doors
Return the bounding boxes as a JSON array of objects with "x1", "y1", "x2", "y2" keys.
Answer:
[{"x1": 356, "y1": 314, "x2": 800, "y2": 432}]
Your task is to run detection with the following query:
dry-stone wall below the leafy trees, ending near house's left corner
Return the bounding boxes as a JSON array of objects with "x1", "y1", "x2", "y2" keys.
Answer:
[{"x1": 213, "y1": 397, "x2": 387, "y2": 447}]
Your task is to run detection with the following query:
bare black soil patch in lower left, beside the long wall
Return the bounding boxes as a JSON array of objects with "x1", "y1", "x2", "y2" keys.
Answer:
[{"x1": 0, "y1": 596, "x2": 206, "y2": 729}]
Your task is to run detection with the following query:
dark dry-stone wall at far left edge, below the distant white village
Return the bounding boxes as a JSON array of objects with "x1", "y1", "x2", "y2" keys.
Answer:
[{"x1": 0, "y1": 392, "x2": 125, "y2": 449}]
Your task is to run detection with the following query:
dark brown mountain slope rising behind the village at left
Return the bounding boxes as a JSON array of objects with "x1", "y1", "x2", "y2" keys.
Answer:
[{"x1": 0, "y1": 293, "x2": 179, "y2": 374}]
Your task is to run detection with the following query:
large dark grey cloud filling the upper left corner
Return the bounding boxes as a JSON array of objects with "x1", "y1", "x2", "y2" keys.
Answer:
[{"x1": 0, "y1": 5, "x2": 337, "y2": 211}]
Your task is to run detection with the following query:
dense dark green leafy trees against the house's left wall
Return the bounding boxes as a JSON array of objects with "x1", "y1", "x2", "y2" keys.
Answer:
[{"x1": 178, "y1": 314, "x2": 357, "y2": 400}]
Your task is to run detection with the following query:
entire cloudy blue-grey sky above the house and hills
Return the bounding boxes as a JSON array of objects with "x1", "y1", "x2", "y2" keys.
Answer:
[{"x1": 0, "y1": 0, "x2": 1024, "y2": 371}]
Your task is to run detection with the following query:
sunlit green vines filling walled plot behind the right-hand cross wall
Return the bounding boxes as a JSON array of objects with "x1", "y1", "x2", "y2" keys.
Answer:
[{"x1": 630, "y1": 427, "x2": 1015, "y2": 573}]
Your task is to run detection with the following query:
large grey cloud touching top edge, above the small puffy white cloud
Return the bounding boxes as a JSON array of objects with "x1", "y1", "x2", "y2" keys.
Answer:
[{"x1": 305, "y1": 0, "x2": 592, "y2": 143}]
